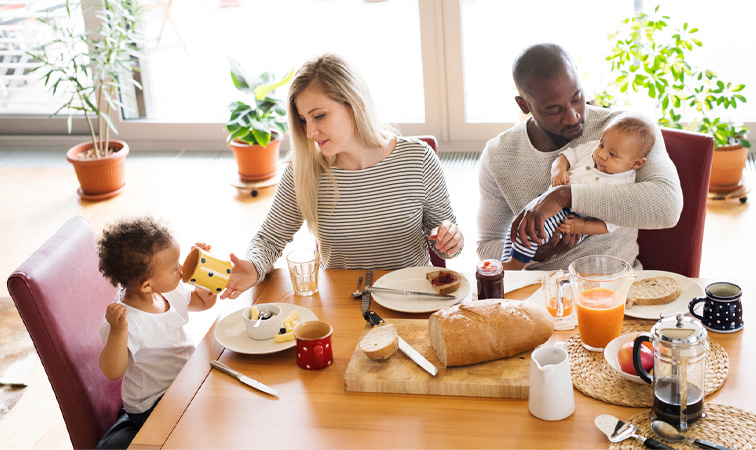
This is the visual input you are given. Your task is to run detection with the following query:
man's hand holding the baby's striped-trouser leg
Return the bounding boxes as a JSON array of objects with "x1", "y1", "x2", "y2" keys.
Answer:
[{"x1": 510, "y1": 186, "x2": 574, "y2": 248}]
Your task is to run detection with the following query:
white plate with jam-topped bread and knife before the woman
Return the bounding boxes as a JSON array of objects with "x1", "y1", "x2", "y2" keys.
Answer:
[{"x1": 372, "y1": 266, "x2": 470, "y2": 313}]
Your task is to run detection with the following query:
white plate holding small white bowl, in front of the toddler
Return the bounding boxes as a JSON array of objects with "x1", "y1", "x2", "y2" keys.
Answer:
[{"x1": 215, "y1": 303, "x2": 318, "y2": 355}]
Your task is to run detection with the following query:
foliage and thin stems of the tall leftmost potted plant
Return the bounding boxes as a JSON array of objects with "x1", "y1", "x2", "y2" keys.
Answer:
[{"x1": 28, "y1": 0, "x2": 142, "y2": 158}]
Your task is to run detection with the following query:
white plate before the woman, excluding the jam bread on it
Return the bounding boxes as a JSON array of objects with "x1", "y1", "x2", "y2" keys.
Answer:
[{"x1": 372, "y1": 266, "x2": 470, "y2": 313}]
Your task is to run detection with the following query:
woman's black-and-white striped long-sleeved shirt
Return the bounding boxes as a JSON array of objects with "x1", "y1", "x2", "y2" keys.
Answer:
[{"x1": 247, "y1": 137, "x2": 459, "y2": 280}]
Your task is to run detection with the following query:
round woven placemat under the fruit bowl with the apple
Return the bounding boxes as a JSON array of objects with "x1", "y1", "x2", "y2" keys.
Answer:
[{"x1": 567, "y1": 318, "x2": 730, "y2": 408}]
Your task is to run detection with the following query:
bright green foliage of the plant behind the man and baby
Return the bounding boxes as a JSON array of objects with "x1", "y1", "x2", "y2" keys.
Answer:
[{"x1": 594, "y1": 6, "x2": 750, "y2": 147}]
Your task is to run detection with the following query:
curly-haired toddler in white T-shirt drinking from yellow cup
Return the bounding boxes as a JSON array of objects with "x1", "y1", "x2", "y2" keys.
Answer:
[{"x1": 97, "y1": 217, "x2": 217, "y2": 448}]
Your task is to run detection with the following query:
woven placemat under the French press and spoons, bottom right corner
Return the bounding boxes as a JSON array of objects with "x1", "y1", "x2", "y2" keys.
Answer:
[{"x1": 609, "y1": 403, "x2": 756, "y2": 450}]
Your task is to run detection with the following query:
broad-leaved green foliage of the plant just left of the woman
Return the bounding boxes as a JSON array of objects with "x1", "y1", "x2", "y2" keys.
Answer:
[{"x1": 226, "y1": 58, "x2": 294, "y2": 147}]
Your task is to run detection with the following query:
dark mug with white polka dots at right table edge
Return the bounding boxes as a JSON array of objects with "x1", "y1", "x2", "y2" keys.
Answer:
[{"x1": 688, "y1": 282, "x2": 743, "y2": 333}]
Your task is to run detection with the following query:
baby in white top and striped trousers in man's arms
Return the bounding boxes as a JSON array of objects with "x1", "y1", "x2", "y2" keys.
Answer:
[{"x1": 502, "y1": 113, "x2": 658, "y2": 270}]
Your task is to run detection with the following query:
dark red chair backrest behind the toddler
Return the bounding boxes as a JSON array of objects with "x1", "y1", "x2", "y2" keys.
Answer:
[{"x1": 8, "y1": 216, "x2": 122, "y2": 448}]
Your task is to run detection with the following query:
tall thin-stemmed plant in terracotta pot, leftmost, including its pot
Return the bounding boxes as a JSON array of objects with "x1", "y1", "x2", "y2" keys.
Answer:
[{"x1": 29, "y1": 0, "x2": 142, "y2": 201}]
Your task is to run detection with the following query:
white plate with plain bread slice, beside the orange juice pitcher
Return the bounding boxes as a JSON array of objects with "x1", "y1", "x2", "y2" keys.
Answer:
[{"x1": 625, "y1": 270, "x2": 704, "y2": 319}]
